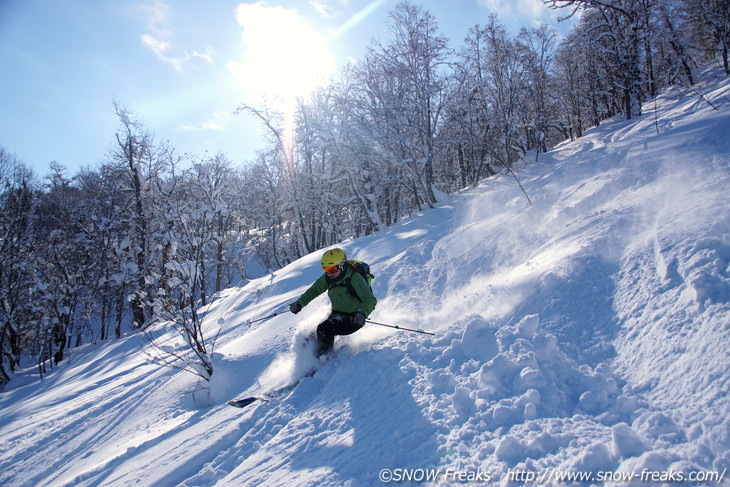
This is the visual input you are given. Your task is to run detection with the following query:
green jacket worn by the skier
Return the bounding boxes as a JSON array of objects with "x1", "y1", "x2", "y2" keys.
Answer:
[{"x1": 297, "y1": 266, "x2": 378, "y2": 317}]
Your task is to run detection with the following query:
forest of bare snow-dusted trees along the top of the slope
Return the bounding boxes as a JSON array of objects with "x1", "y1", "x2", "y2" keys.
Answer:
[{"x1": 0, "y1": 0, "x2": 730, "y2": 387}]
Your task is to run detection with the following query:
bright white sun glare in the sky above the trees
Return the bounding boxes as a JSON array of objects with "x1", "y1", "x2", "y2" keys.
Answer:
[{"x1": 228, "y1": 3, "x2": 335, "y2": 104}]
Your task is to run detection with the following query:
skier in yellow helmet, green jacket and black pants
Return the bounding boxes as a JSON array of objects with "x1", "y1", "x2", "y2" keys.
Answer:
[{"x1": 289, "y1": 248, "x2": 378, "y2": 357}]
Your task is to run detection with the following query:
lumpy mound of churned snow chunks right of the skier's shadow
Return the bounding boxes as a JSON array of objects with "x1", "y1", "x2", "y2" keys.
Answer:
[{"x1": 405, "y1": 315, "x2": 646, "y2": 473}]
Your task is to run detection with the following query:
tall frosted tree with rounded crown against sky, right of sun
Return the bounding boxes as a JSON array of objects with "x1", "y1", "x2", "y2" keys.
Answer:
[{"x1": 363, "y1": 2, "x2": 450, "y2": 208}]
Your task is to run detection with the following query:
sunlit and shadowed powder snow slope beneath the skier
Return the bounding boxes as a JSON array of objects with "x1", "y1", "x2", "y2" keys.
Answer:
[{"x1": 0, "y1": 69, "x2": 730, "y2": 486}]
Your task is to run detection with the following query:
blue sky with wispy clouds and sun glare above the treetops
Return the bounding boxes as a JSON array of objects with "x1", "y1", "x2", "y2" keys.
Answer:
[{"x1": 0, "y1": 0, "x2": 567, "y2": 175}]
